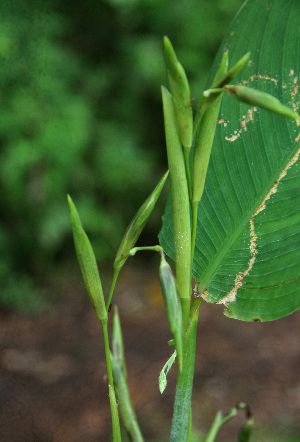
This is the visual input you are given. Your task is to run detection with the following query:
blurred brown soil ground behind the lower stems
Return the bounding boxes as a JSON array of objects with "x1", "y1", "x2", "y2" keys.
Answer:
[{"x1": 0, "y1": 271, "x2": 300, "y2": 442}]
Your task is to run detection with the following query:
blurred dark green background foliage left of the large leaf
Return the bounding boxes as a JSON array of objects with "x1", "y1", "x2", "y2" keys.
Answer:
[{"x1": 0, "y1": 0, "x2": 242, "y2": 311}]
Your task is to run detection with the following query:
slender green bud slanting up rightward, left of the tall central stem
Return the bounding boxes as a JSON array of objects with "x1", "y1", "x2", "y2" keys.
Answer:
[{"x1": 114, "y1": 171, "x2": 169, "y2": 269}]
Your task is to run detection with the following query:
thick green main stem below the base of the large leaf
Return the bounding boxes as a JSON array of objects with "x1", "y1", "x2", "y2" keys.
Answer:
[{"x1": 170, "y1": 298, "x2": 202, "y2": 442}]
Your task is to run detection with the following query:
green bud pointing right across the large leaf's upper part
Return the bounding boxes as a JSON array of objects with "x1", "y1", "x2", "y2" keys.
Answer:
[{"x1": 224, "y1": 86, "x2": 300, "y2": 120}]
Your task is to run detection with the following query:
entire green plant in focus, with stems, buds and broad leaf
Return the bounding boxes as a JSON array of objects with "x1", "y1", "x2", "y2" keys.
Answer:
[{"x1": 69, "y1": 0, "x2": 300, "y2": 442}]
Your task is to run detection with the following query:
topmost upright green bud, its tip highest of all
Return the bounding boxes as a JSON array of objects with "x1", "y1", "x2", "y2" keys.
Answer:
[{"x1": 164, "y1": 36, "x2": 193, "y2": 149}]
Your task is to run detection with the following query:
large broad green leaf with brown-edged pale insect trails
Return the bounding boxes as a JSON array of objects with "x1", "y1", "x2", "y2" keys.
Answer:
[{"x1": 160, "y1": 0, "x2": 300, "y2": 321}]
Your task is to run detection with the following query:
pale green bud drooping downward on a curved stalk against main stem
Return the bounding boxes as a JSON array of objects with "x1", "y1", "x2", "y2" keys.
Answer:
[{"x1": 159, "y1": 252, "x2": 184, "y2": 371}]
